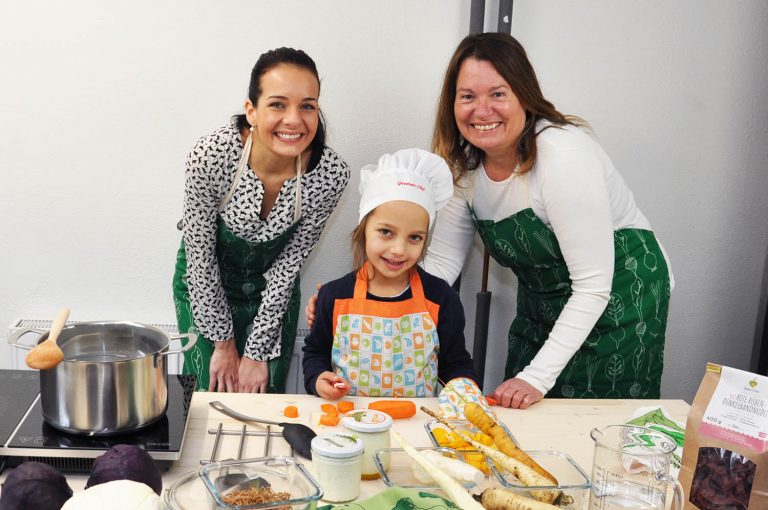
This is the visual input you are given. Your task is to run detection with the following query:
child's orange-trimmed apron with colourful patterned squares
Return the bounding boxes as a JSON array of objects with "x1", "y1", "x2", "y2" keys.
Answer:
[{"x1": 331, "y1": 263, "x2": 440, "y2": 397}]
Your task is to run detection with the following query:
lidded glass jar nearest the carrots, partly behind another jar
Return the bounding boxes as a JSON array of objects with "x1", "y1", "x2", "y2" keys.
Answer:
[{"x1": 341, "y1": 409, "x2": 392, "y2": 480}]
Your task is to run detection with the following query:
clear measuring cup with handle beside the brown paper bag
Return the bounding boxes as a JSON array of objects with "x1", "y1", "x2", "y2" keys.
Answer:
[{"x1": 589, "y1": 425, "x2": 683, "y2": 510}]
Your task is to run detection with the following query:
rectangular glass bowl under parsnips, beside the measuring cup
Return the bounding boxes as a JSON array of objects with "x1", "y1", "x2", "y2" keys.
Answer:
[{"x1": 495, "y1": 450, "x2": 591, "y2": 510}]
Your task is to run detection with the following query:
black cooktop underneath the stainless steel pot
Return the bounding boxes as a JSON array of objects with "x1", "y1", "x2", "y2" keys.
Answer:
[{"x1": 0, "y1": 370, "x2": 195, "y2": 471}]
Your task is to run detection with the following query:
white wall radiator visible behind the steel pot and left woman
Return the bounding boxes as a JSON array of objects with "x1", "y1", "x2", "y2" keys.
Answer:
[{"x1": 8, "y1": 319, "x2": 309, "y2": 393}]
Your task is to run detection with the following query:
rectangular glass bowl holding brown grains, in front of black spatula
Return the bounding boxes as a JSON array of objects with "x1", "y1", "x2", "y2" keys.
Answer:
[{"x1": 198, "y1": 457, "x2": 323, "y2": 510}]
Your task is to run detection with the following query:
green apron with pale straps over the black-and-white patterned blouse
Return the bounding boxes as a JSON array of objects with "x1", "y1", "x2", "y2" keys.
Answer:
[{"x1": 173, "y1": 136, "x2": 301, "y2": 393}]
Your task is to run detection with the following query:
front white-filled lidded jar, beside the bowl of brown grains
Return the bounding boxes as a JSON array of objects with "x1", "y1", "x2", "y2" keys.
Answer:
[{"x1": 311, "y1": 433, "x2": 365, "y2": 503}]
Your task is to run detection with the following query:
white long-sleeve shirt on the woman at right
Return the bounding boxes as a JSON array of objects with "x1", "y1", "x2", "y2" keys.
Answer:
[{"x1": 424, "y1": 121, "x2": 674, "y2": 393}]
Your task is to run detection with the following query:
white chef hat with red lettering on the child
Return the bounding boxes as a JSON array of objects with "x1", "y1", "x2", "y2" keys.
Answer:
[{"x1": 358, "y1": 149, "x2": 453, "y2": 226}]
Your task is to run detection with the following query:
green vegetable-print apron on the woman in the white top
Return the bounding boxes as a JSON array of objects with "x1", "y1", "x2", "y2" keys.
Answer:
[{"x1": 470, "y1": 206, "x2": 670, "y2": 398}]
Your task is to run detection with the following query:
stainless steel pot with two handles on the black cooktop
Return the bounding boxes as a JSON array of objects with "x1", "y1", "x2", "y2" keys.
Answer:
[{"x1": 8, "y1": 321, "x2": 197, "y2": 435}]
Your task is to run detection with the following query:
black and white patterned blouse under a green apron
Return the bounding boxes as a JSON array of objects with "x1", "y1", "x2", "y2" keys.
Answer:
[{"x1": 184, "y1": 123, "x2": 349, "y2": 361}]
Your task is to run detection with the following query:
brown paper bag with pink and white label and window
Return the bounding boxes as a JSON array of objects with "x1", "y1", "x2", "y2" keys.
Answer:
[{"x1": 680, "y1": 363, "x2": 768, "y2": 510}]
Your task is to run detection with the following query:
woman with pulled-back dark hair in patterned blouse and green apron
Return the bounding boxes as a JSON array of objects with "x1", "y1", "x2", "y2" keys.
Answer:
[{"x1": 173, "y1": 48, "x2": 349, "y2": 392}]
